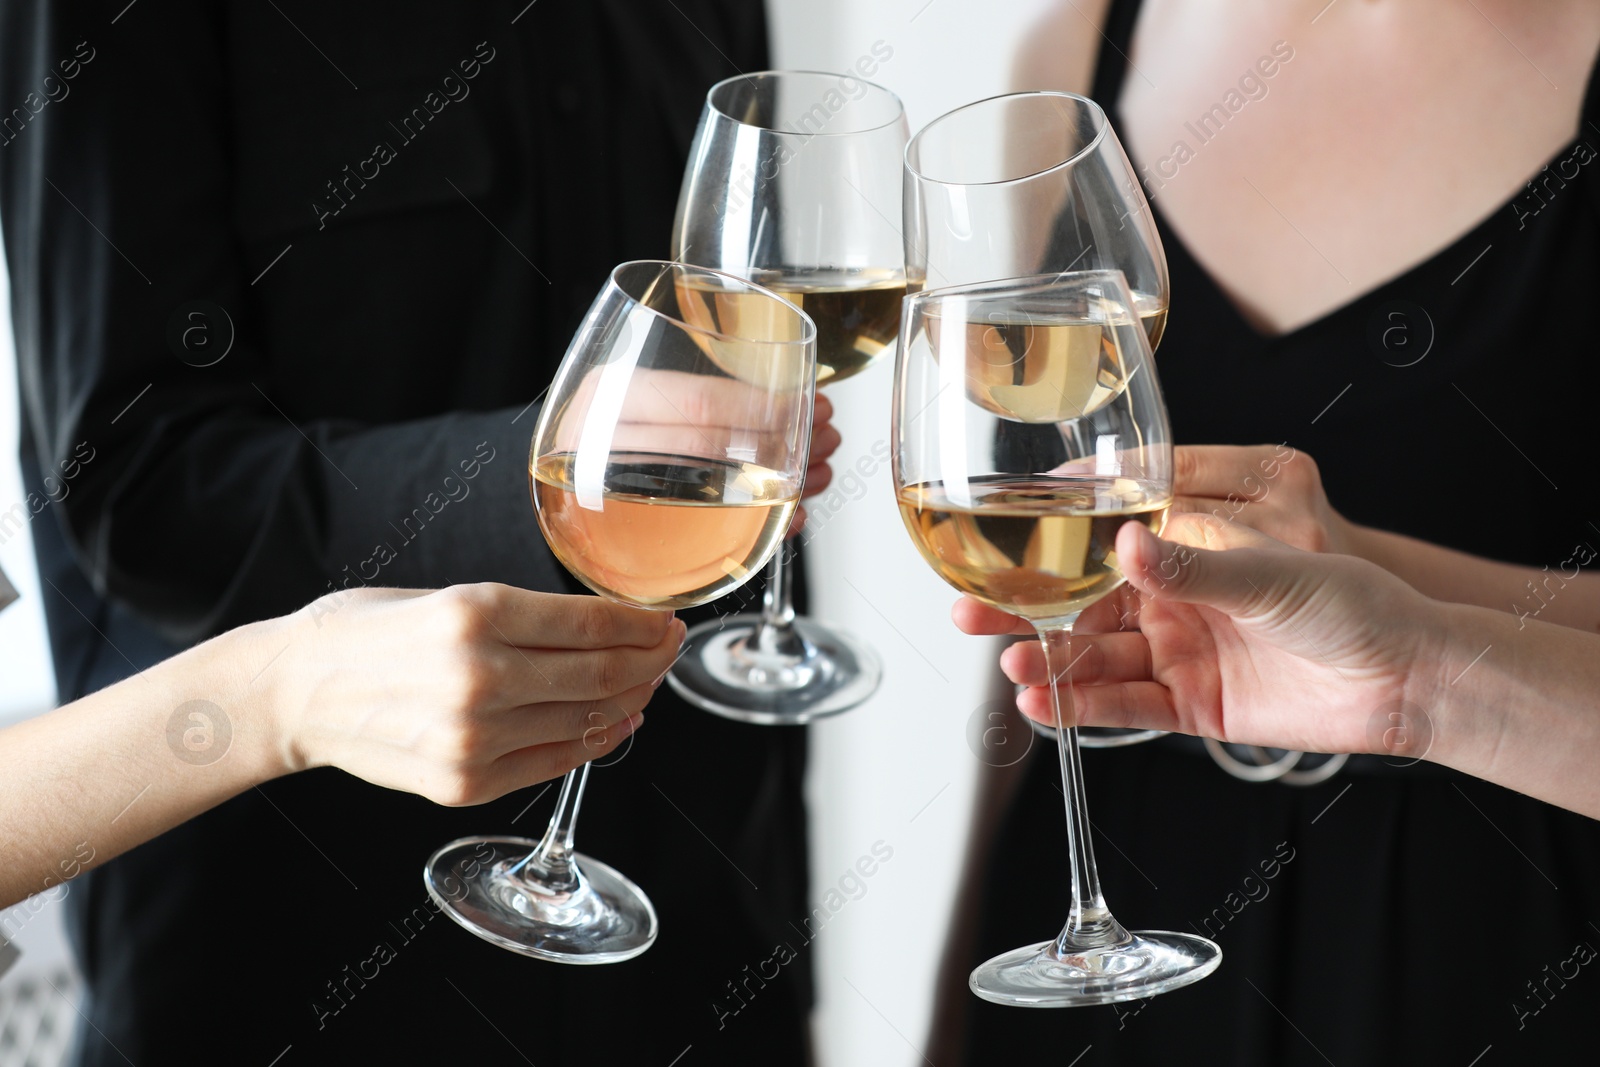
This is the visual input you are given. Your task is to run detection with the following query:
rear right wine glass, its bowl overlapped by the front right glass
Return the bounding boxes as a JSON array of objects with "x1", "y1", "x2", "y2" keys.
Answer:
[{"x1": 906, "y1": 91, "x2": 1170, "y2": 749}]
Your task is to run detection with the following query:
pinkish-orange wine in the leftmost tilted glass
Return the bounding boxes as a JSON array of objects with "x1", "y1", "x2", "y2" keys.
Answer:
[{"x1": 530, "y1": 453, "x2": 800, "y2": 608}]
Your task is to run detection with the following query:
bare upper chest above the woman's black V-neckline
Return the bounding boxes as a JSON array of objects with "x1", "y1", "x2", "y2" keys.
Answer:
[{"x1": 1113, "y1": 0, "x2": 1600, "y2": 334}]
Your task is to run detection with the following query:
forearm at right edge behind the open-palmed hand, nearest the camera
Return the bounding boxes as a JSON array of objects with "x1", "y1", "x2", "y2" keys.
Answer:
[{"x1": 1416, "y1": 605, "x2": 1600, "y2": 819}]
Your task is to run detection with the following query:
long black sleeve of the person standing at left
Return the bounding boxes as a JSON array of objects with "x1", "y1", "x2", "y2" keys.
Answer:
[{"x1": 0, "y1": 0, "x2": 568, "y2": 641}]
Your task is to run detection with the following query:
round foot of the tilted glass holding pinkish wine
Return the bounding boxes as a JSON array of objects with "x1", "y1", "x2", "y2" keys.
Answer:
[{"x1": 422, "y1": 837, "x2": 658, "y2": 965}]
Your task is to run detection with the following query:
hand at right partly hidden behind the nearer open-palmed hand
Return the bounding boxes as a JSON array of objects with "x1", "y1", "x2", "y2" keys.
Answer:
[{"x1": 1173, "y1": 445, "x2": 1355, "y2": 555}]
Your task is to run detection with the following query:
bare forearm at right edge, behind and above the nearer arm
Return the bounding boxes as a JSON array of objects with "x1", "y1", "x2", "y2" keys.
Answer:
[{"x1": 1349, "y1": 525, "x2": 1600, "y2": 633}]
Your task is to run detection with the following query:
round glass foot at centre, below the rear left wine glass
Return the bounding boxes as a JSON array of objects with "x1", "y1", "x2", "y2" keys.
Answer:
[{"x1": 667, "y1": 614, "x2": 883, "y2": 726}]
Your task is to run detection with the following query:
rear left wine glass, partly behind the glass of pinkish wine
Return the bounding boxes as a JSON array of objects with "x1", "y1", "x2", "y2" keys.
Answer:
[{"x1": 669, "y1": 70, "x2": 907, "y2": 725}]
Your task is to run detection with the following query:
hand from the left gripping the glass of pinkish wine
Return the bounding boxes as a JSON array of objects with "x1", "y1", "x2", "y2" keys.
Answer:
[{"x1": 264, "y1": 584, "x2": 685, "y2": 805}]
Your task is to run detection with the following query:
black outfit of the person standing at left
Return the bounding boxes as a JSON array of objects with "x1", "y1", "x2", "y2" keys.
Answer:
[{"x1": 0, "y1": 0, "x2": 814, "y2": 1067}]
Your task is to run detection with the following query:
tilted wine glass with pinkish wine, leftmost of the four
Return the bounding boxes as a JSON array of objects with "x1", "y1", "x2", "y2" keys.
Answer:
[{"x1": 424, "y1": 261, "x2": 816, "y2": 963}]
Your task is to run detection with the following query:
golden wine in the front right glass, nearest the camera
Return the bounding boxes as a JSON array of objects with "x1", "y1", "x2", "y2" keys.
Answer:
[{"x1": 899, "y1": 475, "x2": 1171, "y2": 621}]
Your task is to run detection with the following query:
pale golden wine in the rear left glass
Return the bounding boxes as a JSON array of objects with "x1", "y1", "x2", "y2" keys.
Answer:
[{"x1": 677, "y1": 270, "x2": 906, "y2": 389}]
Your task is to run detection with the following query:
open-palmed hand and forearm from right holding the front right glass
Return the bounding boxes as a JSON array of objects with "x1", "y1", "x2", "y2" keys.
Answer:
[{"x1": 955, "y1": 515, "x2": 1600, "y2": 819}]
